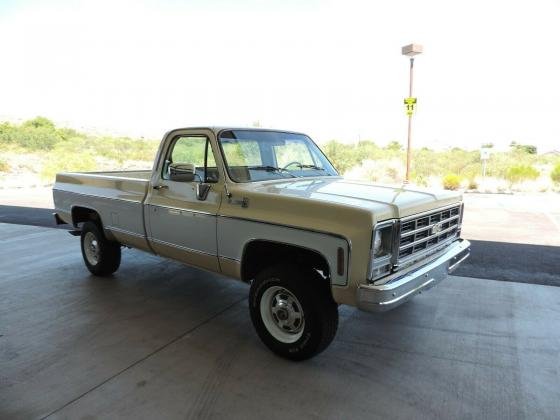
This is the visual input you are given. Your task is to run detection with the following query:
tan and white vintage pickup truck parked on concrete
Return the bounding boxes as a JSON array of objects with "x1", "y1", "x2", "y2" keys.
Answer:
[{"x1": 53, "y1": 127, "x2": 470, "y2": 360}]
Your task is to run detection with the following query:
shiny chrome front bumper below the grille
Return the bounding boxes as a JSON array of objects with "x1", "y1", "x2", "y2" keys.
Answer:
[{"x1": 357, "y1": 239, "x2": 471, "y2": 312}]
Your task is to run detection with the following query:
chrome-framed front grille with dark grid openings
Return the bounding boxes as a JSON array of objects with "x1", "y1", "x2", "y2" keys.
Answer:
[{"x1": 398, "y1": 205, "x2": 461, "y2": 262}]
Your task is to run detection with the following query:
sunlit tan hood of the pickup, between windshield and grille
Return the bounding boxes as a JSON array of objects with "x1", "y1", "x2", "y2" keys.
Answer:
[{"x1": 234, "y1": 177, "x2": 461, "y2": 221}]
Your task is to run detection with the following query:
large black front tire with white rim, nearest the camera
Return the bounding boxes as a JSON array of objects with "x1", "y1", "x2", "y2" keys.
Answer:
[{"x1": 249, "y1": 264, "x2": 338, "y2": 360}]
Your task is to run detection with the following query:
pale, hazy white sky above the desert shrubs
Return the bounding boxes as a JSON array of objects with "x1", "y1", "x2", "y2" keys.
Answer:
[{"x1": 0, "y1": 0, "x2": 560, "y2": 151}]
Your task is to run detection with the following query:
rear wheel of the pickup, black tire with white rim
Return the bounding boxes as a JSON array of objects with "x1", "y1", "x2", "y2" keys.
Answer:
[{"x1": 80, "y1": 222, "x2": 121, "y2": 277}]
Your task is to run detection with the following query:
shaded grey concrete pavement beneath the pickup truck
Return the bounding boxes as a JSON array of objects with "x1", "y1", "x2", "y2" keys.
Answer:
[{"x1": 0, "y1": 224, "x2": 560, "y2": 419}]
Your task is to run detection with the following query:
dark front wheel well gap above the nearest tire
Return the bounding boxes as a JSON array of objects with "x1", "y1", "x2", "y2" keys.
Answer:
[{"x1": 241, "y1": 240, "x2": 330, "y2": 282}]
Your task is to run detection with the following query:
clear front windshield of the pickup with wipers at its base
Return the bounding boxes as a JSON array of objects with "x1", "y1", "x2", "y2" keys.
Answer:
[{"x1": 219, "y1": 130, "x2": 338, "y2": 182}]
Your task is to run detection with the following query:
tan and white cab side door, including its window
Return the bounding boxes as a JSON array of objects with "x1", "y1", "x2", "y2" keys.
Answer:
[{"x1": 145, "y1": 133, "x2": 223, "y2": 271}]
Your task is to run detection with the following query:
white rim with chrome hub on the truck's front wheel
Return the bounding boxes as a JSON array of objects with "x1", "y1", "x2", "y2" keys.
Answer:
[{"x1": 260, "y1": 286, "x2": 305, "y2": 343}]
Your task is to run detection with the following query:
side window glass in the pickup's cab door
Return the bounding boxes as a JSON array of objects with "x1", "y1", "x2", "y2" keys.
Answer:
[{"x1": 162, "y1": 136, "x2": 219, "y2": 183}]
